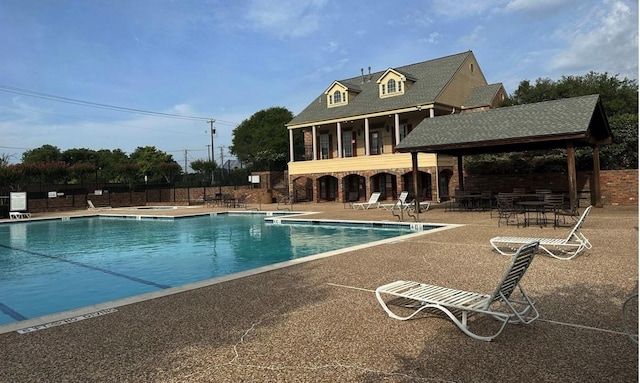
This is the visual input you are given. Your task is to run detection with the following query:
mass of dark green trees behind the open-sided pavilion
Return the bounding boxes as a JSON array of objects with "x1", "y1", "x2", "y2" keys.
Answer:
[{"x1": 465, "y1": 72, "x2": 638, "y2": 174}]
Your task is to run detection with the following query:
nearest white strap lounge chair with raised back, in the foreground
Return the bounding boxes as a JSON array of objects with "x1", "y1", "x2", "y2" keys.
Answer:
[{"x1": 375, "y1": 242, "x2": 539, "y2": 341}]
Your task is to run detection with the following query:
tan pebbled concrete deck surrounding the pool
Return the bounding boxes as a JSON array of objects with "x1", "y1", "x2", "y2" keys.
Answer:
[{"x1": 0, "y1": 203, "x2": 638, "y2": 382}]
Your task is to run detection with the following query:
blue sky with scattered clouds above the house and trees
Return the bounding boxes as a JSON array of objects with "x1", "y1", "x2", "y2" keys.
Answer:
[{"x1": 0, "y1": 0, "x2": 638, "y2": 164}]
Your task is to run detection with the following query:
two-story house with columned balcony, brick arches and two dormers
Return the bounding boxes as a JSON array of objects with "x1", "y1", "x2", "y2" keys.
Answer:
[{"x1": 287, "y1": 51, "x2": 507, "y2": 202}]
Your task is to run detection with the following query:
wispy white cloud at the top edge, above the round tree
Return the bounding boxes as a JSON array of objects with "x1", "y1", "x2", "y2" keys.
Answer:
[{"x1": 245, "y1": 0, "x2": 327, "y2": 38}]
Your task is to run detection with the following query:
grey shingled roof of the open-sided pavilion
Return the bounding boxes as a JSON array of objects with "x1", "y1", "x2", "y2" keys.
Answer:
[{"x1": 396, "y1": 94, "x2": 611, "y2": 155}]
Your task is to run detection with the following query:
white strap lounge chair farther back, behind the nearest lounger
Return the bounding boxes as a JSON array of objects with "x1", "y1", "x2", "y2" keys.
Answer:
[{"x1": 489, "y1": 206, "x2": 592, "y2": 260}]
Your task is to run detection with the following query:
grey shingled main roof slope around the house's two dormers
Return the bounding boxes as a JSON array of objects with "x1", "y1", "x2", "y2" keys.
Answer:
[{"x1": 287, "y1": 51, "x2": 473, "y2": 126}]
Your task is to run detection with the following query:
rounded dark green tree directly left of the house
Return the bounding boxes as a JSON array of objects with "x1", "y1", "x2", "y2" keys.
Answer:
[{"x1": 229, "y1": 107, "x2": 293, "y2": 170}]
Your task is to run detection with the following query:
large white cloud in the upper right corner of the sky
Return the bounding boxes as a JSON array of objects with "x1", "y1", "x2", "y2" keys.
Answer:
[{"x1": 550, "y1": 0, "x2": 638, "y2": 79}]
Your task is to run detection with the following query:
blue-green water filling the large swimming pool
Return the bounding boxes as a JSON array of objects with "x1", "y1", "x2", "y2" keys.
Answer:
[{"x1": 0, "y1": 214, "x2": 424, "y2": 325}]
